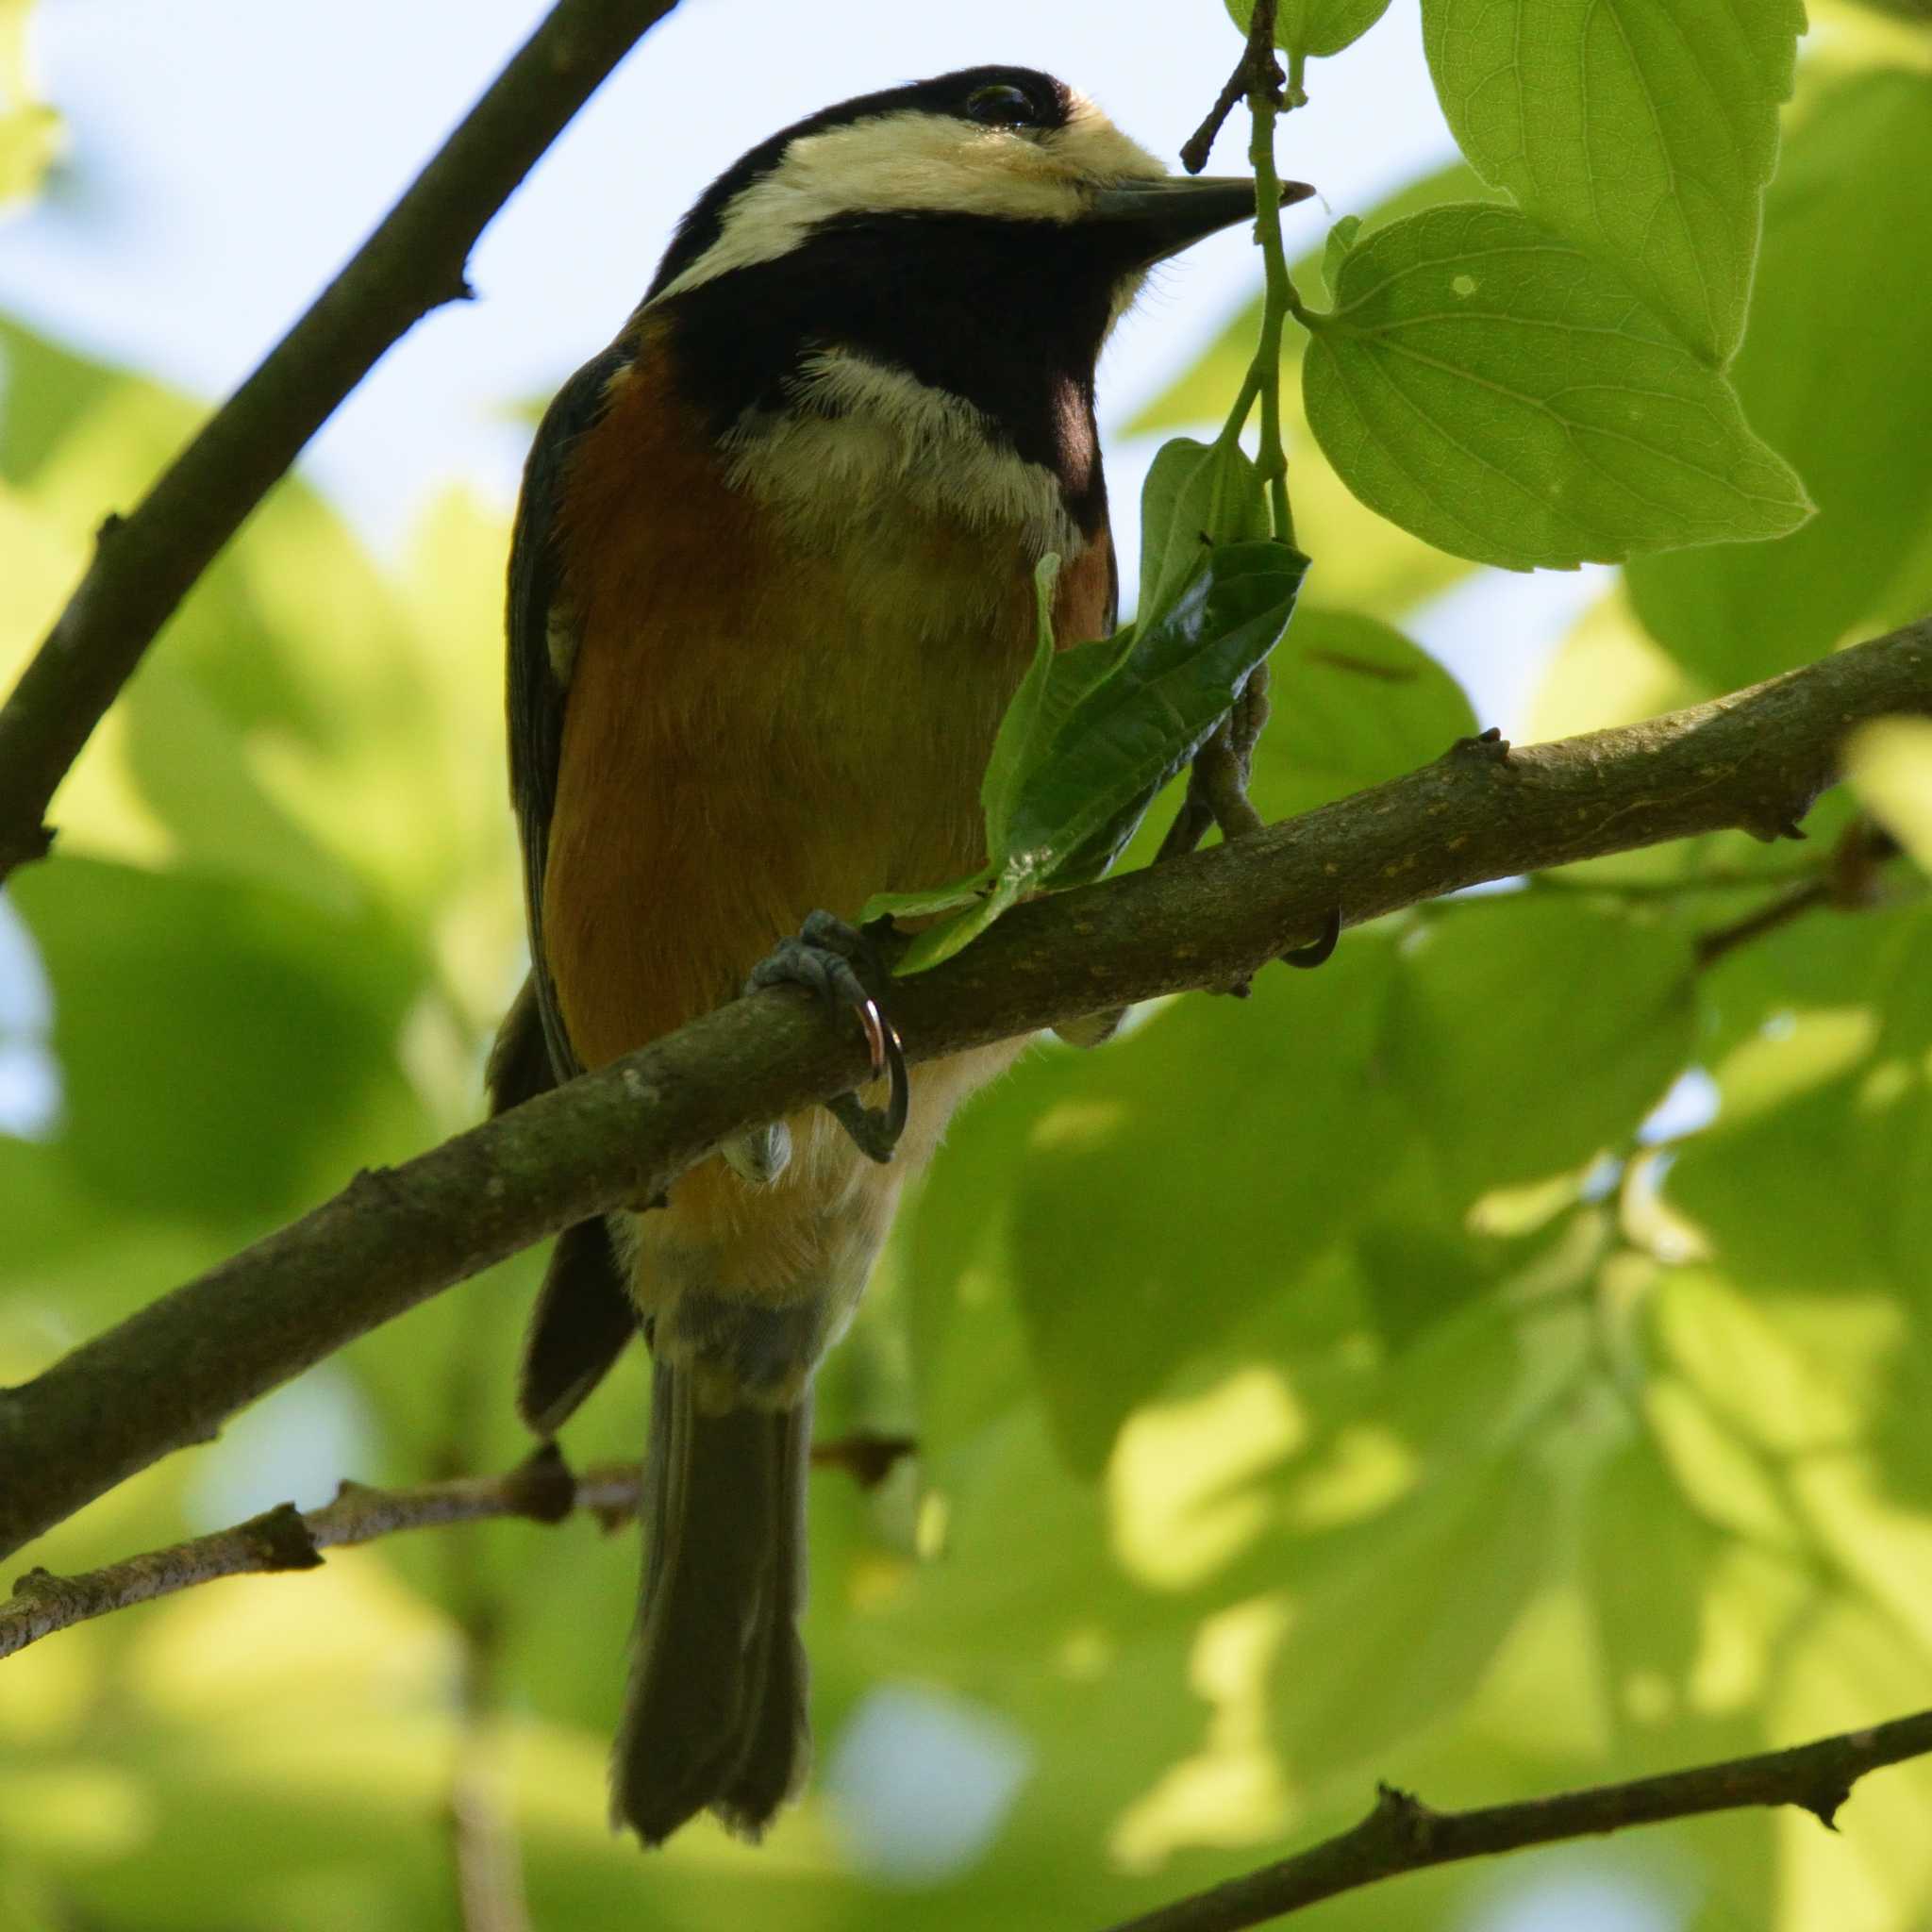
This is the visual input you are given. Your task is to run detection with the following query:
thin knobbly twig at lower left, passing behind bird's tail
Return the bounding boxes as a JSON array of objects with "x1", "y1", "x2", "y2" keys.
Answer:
[{"x1": 0, "y1": 1430, "x2": 916, "y2": 1657}]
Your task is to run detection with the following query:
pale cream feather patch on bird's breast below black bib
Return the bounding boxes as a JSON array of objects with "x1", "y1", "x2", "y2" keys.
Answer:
[{"x1": 724, "y1": 348, "x2": 1086, "y2": 558}]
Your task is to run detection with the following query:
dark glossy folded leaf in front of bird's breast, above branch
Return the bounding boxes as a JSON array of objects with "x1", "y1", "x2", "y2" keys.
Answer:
[{"x1": 1008, "y1": 542, "x2": 1307, "y2": 881}]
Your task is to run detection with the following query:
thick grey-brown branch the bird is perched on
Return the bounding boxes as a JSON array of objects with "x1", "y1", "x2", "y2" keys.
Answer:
[{"x1": 0, "y1": 620, "x2": 1932, "y2": 1556}]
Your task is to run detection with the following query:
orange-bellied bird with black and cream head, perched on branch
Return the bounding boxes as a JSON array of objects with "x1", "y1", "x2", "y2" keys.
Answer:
[{"x1": 491, "y1": 68, "x2": 1307, "y2": 1843}]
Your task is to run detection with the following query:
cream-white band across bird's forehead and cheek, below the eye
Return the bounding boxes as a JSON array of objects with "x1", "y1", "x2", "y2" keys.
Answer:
[{"x1": 657, "y1": 98, "x2": 1167, "y2": 301}]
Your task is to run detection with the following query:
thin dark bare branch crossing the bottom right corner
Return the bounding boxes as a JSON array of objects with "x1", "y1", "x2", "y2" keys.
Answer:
[{"x1": 1109, "y1": 1709, "x2": 1932, "y2": 1932}]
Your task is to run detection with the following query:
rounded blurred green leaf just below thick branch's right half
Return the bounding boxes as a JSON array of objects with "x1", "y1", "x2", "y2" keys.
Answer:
[{"x1": 1385, "y1": 894, "x2": 1694, "y2": 1198}]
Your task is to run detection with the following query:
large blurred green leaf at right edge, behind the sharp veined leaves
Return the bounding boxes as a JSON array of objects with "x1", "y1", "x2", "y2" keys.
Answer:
[{"x1": 1628, "y1": 72, "x2": 1932, "y2": 690}]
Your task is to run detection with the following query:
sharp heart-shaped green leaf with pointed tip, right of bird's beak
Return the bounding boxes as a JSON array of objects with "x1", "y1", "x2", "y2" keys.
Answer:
[{"x1": 1302, "y1": 205, "x2": 1810, "y2": 570}]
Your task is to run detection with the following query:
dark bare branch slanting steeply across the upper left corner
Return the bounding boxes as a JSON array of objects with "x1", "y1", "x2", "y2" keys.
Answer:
[{"x1": 0, "y1": 0, "x2": 676, "y2": 881}]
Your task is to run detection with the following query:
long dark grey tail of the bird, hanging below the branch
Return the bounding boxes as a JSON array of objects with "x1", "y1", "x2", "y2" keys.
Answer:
[{"x1": 610, "y1": 1362, "x2": 811, "y2": 1845}]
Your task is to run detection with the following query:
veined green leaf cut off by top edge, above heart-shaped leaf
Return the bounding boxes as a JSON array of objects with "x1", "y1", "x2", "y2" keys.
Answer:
[{"x1": 1422, "y1": 0, "x2": 1805, "y2": 367}]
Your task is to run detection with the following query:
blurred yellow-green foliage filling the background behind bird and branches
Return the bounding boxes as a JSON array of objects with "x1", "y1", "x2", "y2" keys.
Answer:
[{"x1": 0, "y1": 11, "x2": 1932, "y2": 1932}]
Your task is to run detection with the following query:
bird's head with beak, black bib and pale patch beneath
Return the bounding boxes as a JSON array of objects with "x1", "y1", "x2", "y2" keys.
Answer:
[{"x1": 640, "y1": 68, "x2": 1312, "y2": 551}]
